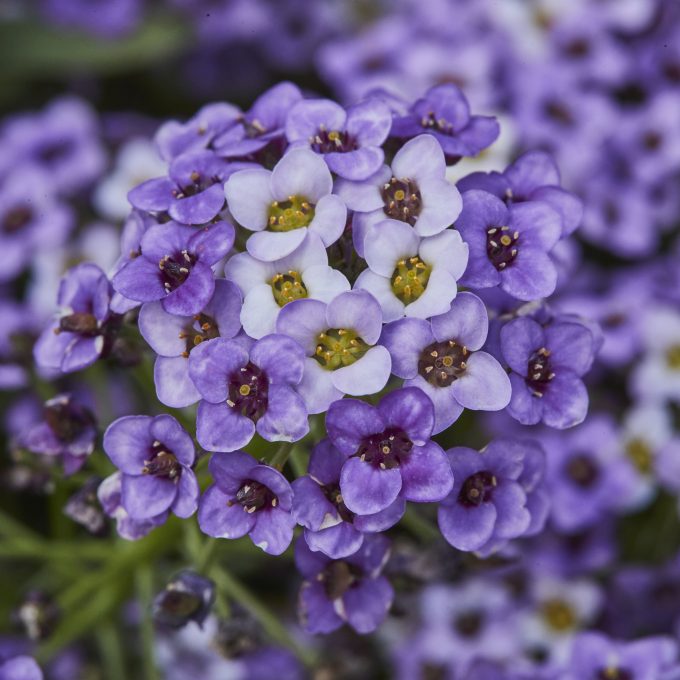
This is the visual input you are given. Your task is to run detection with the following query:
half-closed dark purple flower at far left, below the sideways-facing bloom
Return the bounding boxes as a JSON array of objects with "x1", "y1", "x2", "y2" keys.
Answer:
[{"x1": 19, "y1": 394, "x2": 97, "y2": 475}]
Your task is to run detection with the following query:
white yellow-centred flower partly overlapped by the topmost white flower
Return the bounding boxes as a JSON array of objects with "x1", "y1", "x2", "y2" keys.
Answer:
[{"x1": 224, "y1": 233, "x2": 350, "y2": 339}]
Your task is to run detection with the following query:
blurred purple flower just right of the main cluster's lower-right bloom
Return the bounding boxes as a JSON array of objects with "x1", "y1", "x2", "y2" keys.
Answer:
[{"x1": 542, "y1": 415, "x2": 636, "y2": 534}]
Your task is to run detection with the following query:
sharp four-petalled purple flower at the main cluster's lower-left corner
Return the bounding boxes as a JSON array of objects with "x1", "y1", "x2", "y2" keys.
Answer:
[{"x1": 104, "y1": 415, "x2": 199, "y2": 520}]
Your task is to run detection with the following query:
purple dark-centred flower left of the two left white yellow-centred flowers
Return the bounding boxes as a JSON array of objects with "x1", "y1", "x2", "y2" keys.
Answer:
[{"x1": 112, "y1": 222, "x2": 234, "y2": 316}]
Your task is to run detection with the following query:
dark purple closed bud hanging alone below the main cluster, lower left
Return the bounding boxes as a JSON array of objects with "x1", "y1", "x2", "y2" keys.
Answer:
[{"x1": 153, "y1": 569, "x2": 215, "y2": 628}]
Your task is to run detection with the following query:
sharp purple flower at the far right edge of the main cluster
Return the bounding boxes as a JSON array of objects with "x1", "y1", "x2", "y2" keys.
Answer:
[{"x1": 500, "y1": 317, "x2": 595, "y2": 429}]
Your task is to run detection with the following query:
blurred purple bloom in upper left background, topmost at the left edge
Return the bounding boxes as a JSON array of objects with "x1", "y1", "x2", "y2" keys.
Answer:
[{"x1": 0, "y1": 98, "x2": 106, "y2": 195}]
